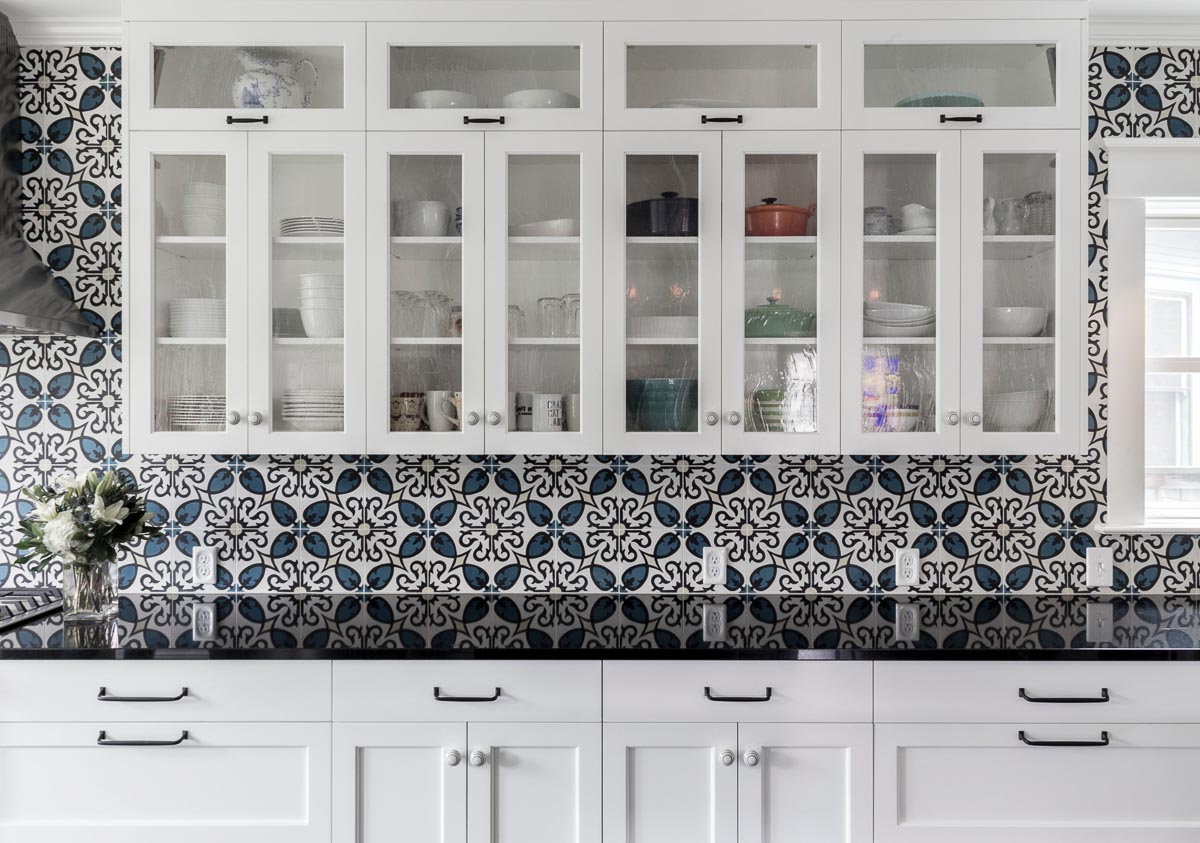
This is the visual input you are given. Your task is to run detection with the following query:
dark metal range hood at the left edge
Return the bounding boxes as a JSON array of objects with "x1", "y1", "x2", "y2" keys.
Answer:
[{"x1": 0, "y1": 14, "x2": 98, "y2": 336}]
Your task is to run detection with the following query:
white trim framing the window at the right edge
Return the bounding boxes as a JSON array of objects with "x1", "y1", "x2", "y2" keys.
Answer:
[{"x1": 1100, "y1": 138, "x2": 1200, "y2": 533}]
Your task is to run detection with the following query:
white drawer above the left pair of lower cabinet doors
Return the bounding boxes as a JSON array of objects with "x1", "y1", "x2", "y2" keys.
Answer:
[{"x1": 334, "y1": 660, "x2": 600, "y2": 723}]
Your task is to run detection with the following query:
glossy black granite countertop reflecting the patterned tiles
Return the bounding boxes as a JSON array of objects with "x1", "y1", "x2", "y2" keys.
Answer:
[{"x1": 0, "y1": 594, "x2": 1200, "y2": 659}]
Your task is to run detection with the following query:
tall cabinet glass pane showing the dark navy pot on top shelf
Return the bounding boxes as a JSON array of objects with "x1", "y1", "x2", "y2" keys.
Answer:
[{"x1": 625, "y1": 155, "x2": 700, "y2": 432}]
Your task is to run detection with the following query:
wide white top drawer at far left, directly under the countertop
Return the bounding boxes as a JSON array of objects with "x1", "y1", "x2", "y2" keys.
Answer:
[{"x1": 0, "y1": 660, "x2": 330, "y2": 723}]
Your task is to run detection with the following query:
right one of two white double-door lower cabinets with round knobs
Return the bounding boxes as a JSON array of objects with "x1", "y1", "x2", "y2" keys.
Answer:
[{"x1": 604, "y1": 723, "x2": 871, "y2": 843}]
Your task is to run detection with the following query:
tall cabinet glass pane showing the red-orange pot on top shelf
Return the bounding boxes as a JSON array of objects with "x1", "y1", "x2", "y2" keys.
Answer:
[{"x1": 743, "y1": 155, "x2": 817, "y2": 434}]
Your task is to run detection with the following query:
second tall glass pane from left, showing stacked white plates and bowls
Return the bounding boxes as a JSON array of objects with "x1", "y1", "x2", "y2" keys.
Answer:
[{"x1": 270, "y1": 155, "x2": 345, "y2": 432}]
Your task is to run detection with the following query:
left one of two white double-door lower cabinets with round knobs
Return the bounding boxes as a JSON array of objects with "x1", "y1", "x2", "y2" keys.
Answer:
[{"x1": 334, "y1": 723, "x2": 600, "y2": 843}]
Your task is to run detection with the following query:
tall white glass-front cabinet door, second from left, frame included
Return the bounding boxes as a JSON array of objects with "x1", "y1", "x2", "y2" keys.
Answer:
[{"x1": 247, "y1": 132, "x2": 366, "y2": 454}]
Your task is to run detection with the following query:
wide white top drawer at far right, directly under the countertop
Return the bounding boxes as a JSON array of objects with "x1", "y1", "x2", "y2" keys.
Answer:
[{"x1": 875, "y1": 662, "x2": 1200, "y2": 723}]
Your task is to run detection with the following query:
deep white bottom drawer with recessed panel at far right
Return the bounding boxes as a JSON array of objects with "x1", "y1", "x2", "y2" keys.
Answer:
[{"x1": 875, "y1": 723, "x2": 1200, "y2": 843}]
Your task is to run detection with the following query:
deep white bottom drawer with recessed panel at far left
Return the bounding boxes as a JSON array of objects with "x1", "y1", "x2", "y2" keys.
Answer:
[{"x1": 0, "y1": 723, "x2": 330, "y2": 843}]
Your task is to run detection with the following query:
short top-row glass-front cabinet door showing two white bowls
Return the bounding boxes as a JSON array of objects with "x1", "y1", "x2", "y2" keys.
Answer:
[{"x1": 367, "y1": 22, "x2": 604, "y2": 131}]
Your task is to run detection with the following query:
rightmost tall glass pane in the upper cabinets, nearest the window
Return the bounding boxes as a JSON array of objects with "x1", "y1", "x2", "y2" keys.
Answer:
[{"x1": 983, "y1": 153, "x2": 1058, "y2": 432}]
